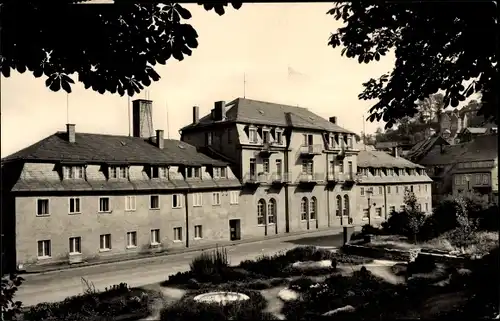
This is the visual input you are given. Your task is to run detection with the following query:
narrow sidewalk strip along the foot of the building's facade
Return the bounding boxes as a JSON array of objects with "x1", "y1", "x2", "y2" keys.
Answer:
[{"x1": 22, "y1": 227, "x2": 352, "y2": 274}]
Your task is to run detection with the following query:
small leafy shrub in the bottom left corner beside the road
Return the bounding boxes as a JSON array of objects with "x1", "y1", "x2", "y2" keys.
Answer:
[{"x1": 0, "y1": 274, "x2": 24, "y2": 320}]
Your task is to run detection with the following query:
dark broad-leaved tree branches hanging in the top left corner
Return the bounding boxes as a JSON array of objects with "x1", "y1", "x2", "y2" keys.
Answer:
[{"x1": 0, "y1": 0, "x2": 241, "y2": 96}]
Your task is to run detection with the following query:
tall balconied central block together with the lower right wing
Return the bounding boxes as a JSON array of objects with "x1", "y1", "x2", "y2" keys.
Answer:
[{"x1": 181, "y1": 98, "x2": 432, "y2": 230}]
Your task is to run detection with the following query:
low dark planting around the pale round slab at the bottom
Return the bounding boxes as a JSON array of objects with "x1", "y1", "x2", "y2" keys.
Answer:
[{"x1": 160, "y1": 286, "x2": 277, "y2": 321}]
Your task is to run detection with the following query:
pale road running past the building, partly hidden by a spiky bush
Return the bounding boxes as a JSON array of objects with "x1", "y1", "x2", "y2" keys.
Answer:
[{"x1": 15, "y1": 232, "x2": 342, "y2": 306}]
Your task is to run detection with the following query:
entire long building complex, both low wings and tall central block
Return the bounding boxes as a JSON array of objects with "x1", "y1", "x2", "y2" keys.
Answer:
[{"x1": 1, "y1": 98, "x2": 431, "y2": 270}]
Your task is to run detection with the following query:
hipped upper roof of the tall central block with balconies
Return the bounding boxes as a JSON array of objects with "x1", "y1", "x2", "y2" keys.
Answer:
[{"x1": 181, "y1": 98, "x2": 354, "y2": 134}]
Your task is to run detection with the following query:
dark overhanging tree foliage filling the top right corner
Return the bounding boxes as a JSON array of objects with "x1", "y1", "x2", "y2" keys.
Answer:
[{"x1": 328, "y1": 1, "x2": 498, "y2": 128}]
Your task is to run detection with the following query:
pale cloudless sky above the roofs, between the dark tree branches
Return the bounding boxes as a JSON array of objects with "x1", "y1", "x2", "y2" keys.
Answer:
[{"x1": 1, "y1": 3, "x2": 394, "y2": 157}]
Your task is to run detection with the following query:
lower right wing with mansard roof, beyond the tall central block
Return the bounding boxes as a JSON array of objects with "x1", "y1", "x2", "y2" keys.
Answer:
[{"x1": 357, "y1": 147, "x2": 432, "y2": 225}]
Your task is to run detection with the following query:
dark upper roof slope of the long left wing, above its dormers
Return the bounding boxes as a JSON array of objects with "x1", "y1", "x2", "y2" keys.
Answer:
[{"x1": 2, "y1": 132, "x2": 227, "y2": 166}]
